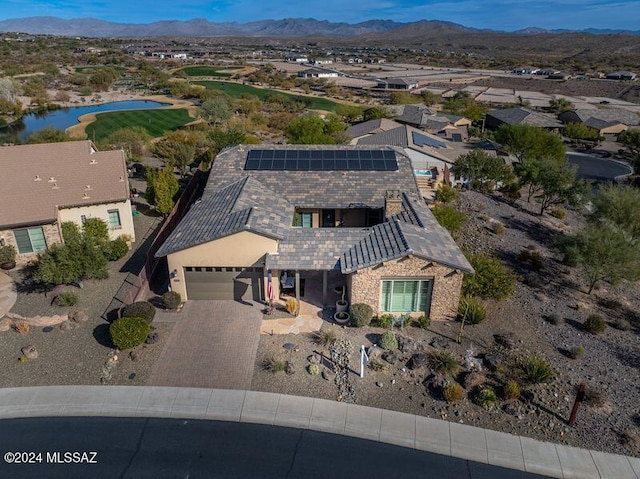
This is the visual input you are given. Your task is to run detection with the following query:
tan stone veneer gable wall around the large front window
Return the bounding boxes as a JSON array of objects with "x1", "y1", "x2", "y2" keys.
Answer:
[{"x1": 348, "y1": 256, "x2": 463, "y2": 321}]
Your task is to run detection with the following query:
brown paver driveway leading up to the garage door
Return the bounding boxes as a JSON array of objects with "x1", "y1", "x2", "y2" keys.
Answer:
[{"x1": 147, "y1": 301, "x2": 262, "y2": 389}]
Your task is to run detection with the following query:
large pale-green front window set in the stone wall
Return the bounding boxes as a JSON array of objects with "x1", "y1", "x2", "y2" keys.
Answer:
[{"x1": 380, "y1": 279, "x2": 433, "y2": 314}]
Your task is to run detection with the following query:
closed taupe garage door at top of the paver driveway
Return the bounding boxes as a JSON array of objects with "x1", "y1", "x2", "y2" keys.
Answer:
[{"x1": 184, "y1": 266, "x2": 262, "y2": 301}]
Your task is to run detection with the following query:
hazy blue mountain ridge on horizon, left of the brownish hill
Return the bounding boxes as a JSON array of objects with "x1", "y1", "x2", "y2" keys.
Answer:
[{"x1": 0, "y1": 17, "x2": 405, "y2": 37}]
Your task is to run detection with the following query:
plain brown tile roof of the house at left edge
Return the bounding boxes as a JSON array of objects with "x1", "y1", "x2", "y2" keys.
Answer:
[{"x1": 0, "y1": 140, "x2": 129, "y2": 226}]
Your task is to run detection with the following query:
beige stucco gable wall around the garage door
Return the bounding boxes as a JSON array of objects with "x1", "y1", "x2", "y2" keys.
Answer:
[{"x1": 167, "y1": 231, "x2": 278, "y2": 299}]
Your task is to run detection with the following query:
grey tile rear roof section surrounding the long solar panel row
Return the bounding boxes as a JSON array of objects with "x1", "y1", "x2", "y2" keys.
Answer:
[{"x1": 205, "y1": 145, "x2": 418, "y2": 208}]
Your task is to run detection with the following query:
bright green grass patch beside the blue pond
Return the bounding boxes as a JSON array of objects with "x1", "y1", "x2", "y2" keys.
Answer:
[{"x1": 86, "y1": 108, "x2": 194, "y2": 141}]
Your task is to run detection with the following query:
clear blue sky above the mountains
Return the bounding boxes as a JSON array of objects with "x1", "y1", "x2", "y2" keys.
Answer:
[{"x1": 0, "y1": 0, "x2": 640, "y2": 31}]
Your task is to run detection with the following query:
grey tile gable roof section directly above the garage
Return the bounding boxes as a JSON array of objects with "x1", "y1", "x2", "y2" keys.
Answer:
[{"x1": 156, "y1": 176, "x2": 294, "y2": 258}]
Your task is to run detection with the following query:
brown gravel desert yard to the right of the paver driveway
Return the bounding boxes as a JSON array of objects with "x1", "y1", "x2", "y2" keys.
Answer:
[{"x1": 252, "y1": 192, "x2": 640, "y2": 455}]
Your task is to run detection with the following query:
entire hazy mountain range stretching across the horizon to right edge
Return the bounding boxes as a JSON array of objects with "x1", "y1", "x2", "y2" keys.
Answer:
[{"x1": 0, "y1": 17, "x2": 640, "y2": 39}]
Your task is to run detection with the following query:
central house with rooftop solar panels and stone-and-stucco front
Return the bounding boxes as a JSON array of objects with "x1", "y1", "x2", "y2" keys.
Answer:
[{"x1": 156, "y1": 145, "x2": 473, "y2": 320}]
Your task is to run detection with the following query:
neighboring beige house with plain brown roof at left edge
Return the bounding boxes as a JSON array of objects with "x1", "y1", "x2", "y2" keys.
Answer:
[{"x1": 0, "y1": 141, "x2": 135, "y2": 263}]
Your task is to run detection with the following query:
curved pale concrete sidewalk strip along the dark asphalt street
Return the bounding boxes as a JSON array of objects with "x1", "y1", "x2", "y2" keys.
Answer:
[{"x1": 0, "y1": 386, "x2": 640, "y2": 479}]
